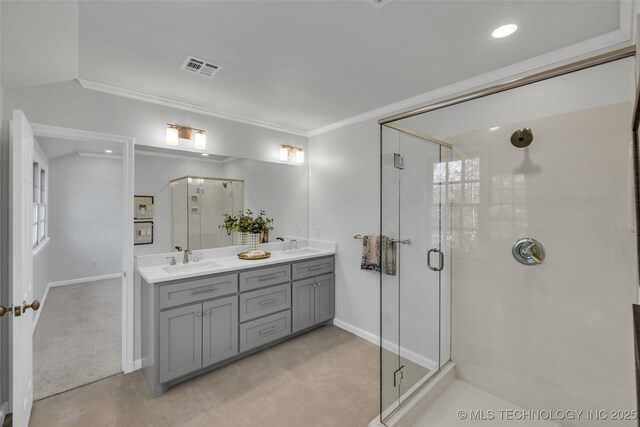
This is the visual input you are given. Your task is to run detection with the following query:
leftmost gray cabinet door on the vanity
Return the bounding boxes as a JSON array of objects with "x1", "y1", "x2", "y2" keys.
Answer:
[{"x1": 158, "y1": 304, "x2": 202, "y2": 382}]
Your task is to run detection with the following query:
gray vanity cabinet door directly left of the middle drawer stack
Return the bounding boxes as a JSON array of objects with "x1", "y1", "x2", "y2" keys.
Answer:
[{"x1": 202, "y1": 295, "x2": 238, "y2": 367}]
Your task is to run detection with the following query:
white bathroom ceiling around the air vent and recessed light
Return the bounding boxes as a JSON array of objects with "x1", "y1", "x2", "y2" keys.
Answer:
[{"x1": 2, "y1": 0, "x2": 632, "y2": 132}]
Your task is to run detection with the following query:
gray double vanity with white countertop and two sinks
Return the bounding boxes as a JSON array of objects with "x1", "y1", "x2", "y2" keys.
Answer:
[{"x1": 137, "y1": 241, "x2": 335, "y2": 396}]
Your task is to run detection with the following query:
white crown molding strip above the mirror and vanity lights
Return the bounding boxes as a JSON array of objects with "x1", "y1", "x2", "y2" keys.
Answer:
[{"x1": 77, "y1": 78, "x2": 308, "y2": 137}]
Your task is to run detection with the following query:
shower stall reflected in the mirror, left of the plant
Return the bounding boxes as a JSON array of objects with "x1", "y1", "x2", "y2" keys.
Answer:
[{"x1": 171, "y1": 176, "x2": 244, "y2": 250}]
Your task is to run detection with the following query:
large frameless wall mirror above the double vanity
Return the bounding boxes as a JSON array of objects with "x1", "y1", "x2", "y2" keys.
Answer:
[{"x1": 135, "y1": 146, "x2": 309, "y2": 255}]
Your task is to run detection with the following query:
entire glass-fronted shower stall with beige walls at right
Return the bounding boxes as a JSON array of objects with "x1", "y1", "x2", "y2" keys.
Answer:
[{"x1": 379, "y1": 49, "x2": 638, "y2": 427}]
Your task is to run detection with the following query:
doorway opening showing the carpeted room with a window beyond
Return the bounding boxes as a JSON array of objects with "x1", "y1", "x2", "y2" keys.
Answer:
[{"x1": 32, "y1": 135, "x2": 124, "y2": 400}]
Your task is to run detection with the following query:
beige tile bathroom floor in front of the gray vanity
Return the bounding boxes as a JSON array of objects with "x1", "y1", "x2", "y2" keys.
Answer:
[{"x1": 31, "y1": 326, "x2": 379, "y2": 427}]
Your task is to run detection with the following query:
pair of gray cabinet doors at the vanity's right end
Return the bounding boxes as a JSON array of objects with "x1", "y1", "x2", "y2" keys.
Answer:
[{"x1": 291, "y1": 273, "x2": 335, "y2": 332}]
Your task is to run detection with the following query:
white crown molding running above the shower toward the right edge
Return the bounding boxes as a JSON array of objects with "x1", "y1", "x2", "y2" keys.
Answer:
[{"x1": 308, "y1": 28, "x2": 633, "y2": 138}]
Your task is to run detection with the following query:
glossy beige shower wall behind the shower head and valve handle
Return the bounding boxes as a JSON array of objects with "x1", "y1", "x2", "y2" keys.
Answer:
[{"x1": 400, "y1": 59, "x2": 638, "y2": 425}]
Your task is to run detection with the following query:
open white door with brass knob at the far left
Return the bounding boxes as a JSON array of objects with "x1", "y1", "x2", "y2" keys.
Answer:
[{"x1": 9, "y1": 110, "x2": 39, "y2": 427}]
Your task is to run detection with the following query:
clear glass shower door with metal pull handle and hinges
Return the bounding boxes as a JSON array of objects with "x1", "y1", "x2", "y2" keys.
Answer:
[{"x1": 380, "y1": 126, "x2": 451, "y2": 421}]
